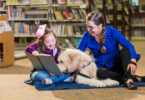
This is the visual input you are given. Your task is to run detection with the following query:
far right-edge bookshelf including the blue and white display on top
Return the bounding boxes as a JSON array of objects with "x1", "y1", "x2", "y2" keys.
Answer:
[{"x1": 131, "y1": 0, "x2": 145, "y2": 40}]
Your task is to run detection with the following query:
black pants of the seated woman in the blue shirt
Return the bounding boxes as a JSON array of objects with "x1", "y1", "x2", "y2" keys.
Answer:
[{"x1": 97, "y1": 48, "x2": 136, "y2": 83}]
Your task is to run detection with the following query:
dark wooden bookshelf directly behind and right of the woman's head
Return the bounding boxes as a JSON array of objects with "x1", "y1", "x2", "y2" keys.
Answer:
[{"x1": 103, "y1": 0, "x2": 132, "y2": 40}]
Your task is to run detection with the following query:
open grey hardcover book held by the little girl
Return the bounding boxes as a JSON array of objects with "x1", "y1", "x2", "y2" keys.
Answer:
[{"x1": 25, "y1": 52, "x2": 63, "y2": 75}]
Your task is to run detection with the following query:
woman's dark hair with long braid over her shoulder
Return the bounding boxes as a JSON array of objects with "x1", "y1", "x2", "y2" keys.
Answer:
[{"x1": 86, "y1": 10, "x2": 106, "y2": 53}]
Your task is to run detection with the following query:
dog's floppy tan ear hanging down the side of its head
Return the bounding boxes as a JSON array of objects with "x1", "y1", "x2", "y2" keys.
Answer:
[{"x1": 68, "y1": 53, "x2": 80, "y2": 72}]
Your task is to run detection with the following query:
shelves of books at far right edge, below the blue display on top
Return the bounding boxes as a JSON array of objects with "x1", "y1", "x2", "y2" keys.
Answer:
[{"x1": 131, "y1": 12, "x2": 145, "y2": 40}]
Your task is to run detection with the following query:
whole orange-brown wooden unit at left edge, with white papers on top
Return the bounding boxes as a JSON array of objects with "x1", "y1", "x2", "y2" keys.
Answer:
[{"x1": 0, "y1": 15, "x2": 14, "y2": 68}]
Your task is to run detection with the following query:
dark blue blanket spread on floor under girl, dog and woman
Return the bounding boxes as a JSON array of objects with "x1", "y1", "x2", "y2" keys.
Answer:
[{"x1": 34, "y1": 82, "x2": 145, "y2": 90}]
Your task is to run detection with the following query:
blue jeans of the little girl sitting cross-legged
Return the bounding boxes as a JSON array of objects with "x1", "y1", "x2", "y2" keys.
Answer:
[{"x1": 30, "y1": 71, "x2": 70, "y2": 83}]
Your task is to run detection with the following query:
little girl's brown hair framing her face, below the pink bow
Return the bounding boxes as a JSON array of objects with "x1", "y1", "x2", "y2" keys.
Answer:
[{"x1": 37, "y1": 29, "x2": 59, "y2": 53}]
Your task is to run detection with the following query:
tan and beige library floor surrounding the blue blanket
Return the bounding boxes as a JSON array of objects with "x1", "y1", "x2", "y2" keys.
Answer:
[{"x1": 0, "y1": 41, "x2": 145, "y2": 100}]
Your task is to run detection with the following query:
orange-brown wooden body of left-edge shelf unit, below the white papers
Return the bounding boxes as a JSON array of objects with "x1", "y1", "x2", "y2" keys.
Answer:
[{"x1": 0, "y1": 31, "x2": 14, "y2": 67}]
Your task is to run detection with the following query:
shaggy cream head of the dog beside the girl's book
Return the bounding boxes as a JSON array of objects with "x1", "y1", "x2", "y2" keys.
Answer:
[{"x1": 58, "y1": 49, "x2": 91, "y2": 73}]
